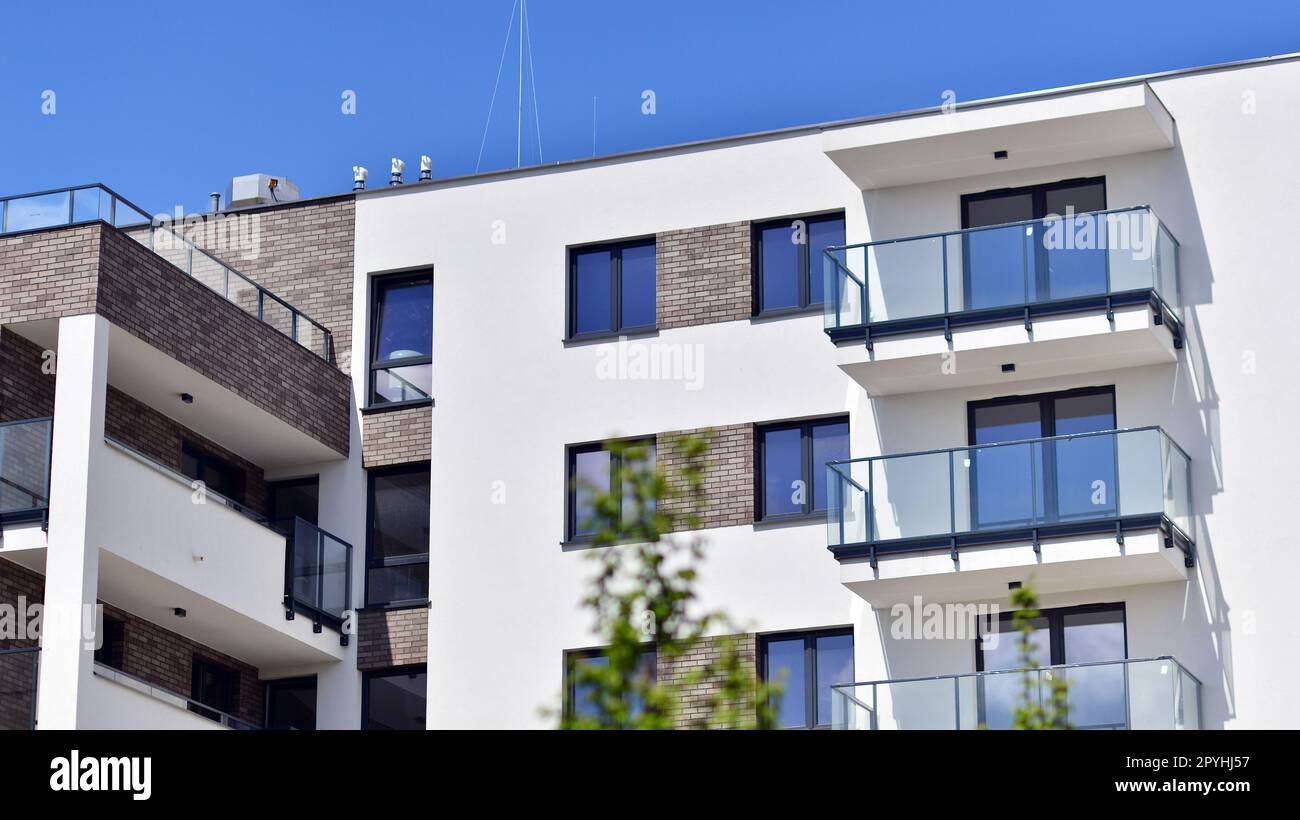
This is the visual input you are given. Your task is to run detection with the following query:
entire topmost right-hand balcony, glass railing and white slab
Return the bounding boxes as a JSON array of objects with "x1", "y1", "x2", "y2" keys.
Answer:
[{"x1": 823, "y1": 207, "x2": 1183, "y2": 395}]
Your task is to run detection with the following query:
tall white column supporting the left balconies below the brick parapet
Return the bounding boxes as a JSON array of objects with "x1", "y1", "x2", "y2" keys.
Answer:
[{"x1": 36, "y1": 314, "x2": 108, "y2": 729}]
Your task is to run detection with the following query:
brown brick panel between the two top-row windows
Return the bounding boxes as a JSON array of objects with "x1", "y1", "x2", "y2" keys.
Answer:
[{"x1": 655, "y1": 222, "x2": 754, "y2": 330}]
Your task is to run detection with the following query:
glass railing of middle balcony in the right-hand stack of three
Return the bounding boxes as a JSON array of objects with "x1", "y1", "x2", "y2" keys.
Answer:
[{"x1": 827, "y1": 426, "x2": 1193, "y2": 563}]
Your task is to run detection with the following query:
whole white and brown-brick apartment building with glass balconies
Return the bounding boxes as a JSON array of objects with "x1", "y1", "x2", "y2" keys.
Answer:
[{"x1": 0, "y1": 56, "x2": 1300, "y2": 730}]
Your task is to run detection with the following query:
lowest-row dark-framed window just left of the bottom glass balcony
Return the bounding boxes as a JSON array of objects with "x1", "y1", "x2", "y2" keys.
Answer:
[{"x1": 758, "y1": 626, "x2": 853, "y2": 729}]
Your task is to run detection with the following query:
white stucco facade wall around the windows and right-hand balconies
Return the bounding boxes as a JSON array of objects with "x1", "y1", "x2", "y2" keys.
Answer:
[{"x1": 354, "y1": 54, "x2": 1300, "y2": 728}]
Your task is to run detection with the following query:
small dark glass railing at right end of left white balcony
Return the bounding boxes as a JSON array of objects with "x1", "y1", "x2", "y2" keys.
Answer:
[{"x1": 285, "y1": 517, "x2": 352, "y2": 646}]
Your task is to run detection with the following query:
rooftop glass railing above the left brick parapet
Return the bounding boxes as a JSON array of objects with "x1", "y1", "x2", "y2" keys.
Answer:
[{"x1": 0, "y1": 183, "x2": 334, "y2": 363}]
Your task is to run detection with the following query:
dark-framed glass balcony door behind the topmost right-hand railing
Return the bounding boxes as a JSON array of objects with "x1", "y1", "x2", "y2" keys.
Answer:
[{"x1": 962, "y1": 177, "x2": 1106, "y2": 309}]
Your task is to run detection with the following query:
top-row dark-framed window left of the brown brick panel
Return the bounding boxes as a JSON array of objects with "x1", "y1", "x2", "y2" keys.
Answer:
[{"x1": 568, "y1": 239, "x2": 655, "y2": 339}]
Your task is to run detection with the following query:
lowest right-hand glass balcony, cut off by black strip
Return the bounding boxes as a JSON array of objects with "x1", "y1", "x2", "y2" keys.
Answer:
[{"x1": 831, "y1": 656, "x2": 1201, "y2": 730}]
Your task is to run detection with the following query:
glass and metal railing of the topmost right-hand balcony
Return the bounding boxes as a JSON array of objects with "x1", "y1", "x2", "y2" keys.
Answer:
[{"x1": 823, "y1": 205, "x2": 1182, "y2": 346}]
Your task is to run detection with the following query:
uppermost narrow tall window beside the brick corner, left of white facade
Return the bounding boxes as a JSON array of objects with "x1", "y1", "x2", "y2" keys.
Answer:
[{"x1": 369, "y1": 272, "x2": 433, "y2": 407}]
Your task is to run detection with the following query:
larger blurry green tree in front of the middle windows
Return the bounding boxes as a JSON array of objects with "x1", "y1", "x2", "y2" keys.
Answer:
[{"x1": 560, "y1": 435, "x2": 780, "y2": 729}]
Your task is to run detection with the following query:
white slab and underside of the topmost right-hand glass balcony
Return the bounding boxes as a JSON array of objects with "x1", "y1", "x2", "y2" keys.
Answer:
[{"x1": 835, "y1": 304, "x2": 1178, "y2": 396}]
